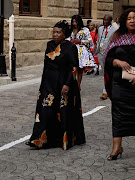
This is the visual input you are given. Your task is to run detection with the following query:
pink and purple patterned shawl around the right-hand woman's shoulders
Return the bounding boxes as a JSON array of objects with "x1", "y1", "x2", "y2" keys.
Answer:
[{"x1": 104, "y1": 33, "x2": 135, "y2": 99}]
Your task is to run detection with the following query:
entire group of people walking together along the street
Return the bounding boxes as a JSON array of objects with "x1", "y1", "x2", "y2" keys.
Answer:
[{"x1": 26, "y1": 10, "x2": 135, "y2": 160}]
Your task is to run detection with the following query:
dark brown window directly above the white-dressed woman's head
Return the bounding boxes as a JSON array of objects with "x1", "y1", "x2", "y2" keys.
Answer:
[{"x1": 79, "y1": 0, "x2": 91, "y2": 18}]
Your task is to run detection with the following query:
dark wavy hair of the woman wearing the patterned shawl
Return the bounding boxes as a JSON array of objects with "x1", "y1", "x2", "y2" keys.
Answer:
[{"x1": 117, "y1": 9, "x2": 135, "y2": 35}]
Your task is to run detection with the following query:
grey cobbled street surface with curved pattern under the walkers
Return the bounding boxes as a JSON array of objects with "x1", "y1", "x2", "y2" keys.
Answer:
[{"x1": 0, "y1": 66, "x2": 135, "y2": 180}]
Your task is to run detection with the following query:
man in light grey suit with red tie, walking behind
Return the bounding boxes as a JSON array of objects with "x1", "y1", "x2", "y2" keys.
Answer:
[{"x1": 96, "y1": 14, "x2": 117, "y2": 100}]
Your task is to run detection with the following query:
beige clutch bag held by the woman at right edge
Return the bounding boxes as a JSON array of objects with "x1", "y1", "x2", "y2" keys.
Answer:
[{"x1": 122, "y1": 66, "x2": 135, "y2": 82}]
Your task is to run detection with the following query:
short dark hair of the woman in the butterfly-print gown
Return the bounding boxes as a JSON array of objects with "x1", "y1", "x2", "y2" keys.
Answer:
[{"x1": 54, "y1": 20, "x2": 71, "y2": 38}]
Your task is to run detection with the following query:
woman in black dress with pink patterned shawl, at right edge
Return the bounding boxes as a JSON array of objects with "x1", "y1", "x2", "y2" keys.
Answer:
[{"x1": 105, "y1": 10, "x2": 135, "y2": 160}]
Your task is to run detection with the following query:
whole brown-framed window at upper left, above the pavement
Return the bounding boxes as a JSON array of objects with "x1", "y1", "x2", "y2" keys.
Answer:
[{"x1": 19, "y1": 0, "x2": 41, "y2": 16}]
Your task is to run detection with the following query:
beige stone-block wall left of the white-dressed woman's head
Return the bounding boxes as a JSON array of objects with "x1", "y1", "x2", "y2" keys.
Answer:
[{"x1": 4, "y1": 0, "x2": 79, "y2": 67}]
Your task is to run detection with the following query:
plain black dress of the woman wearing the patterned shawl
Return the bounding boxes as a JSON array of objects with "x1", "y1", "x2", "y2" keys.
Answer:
[{"x1": 105, "y1": 45, "x2": 135, "y2": 137}]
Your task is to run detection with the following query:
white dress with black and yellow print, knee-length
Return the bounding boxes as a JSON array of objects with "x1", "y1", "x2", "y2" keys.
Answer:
[{"x1": 70, "y1": 27, "x2": 96, "y2": 68}]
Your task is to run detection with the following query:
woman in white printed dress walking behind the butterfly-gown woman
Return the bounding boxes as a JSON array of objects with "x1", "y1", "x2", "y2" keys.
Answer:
[{"x1": 70, "y1": 15, "x2": 96, "y2": 89}]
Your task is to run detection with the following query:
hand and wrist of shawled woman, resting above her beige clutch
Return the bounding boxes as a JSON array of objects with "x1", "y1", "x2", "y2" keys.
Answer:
[{"x1": 113, "y1": 59, "x2": 131, "y2": 71}]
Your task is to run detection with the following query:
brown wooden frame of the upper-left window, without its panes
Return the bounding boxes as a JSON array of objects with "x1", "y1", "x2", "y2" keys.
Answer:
[{"x1": 19, "y1": 0, "x2": 41, "y2": 16}]
